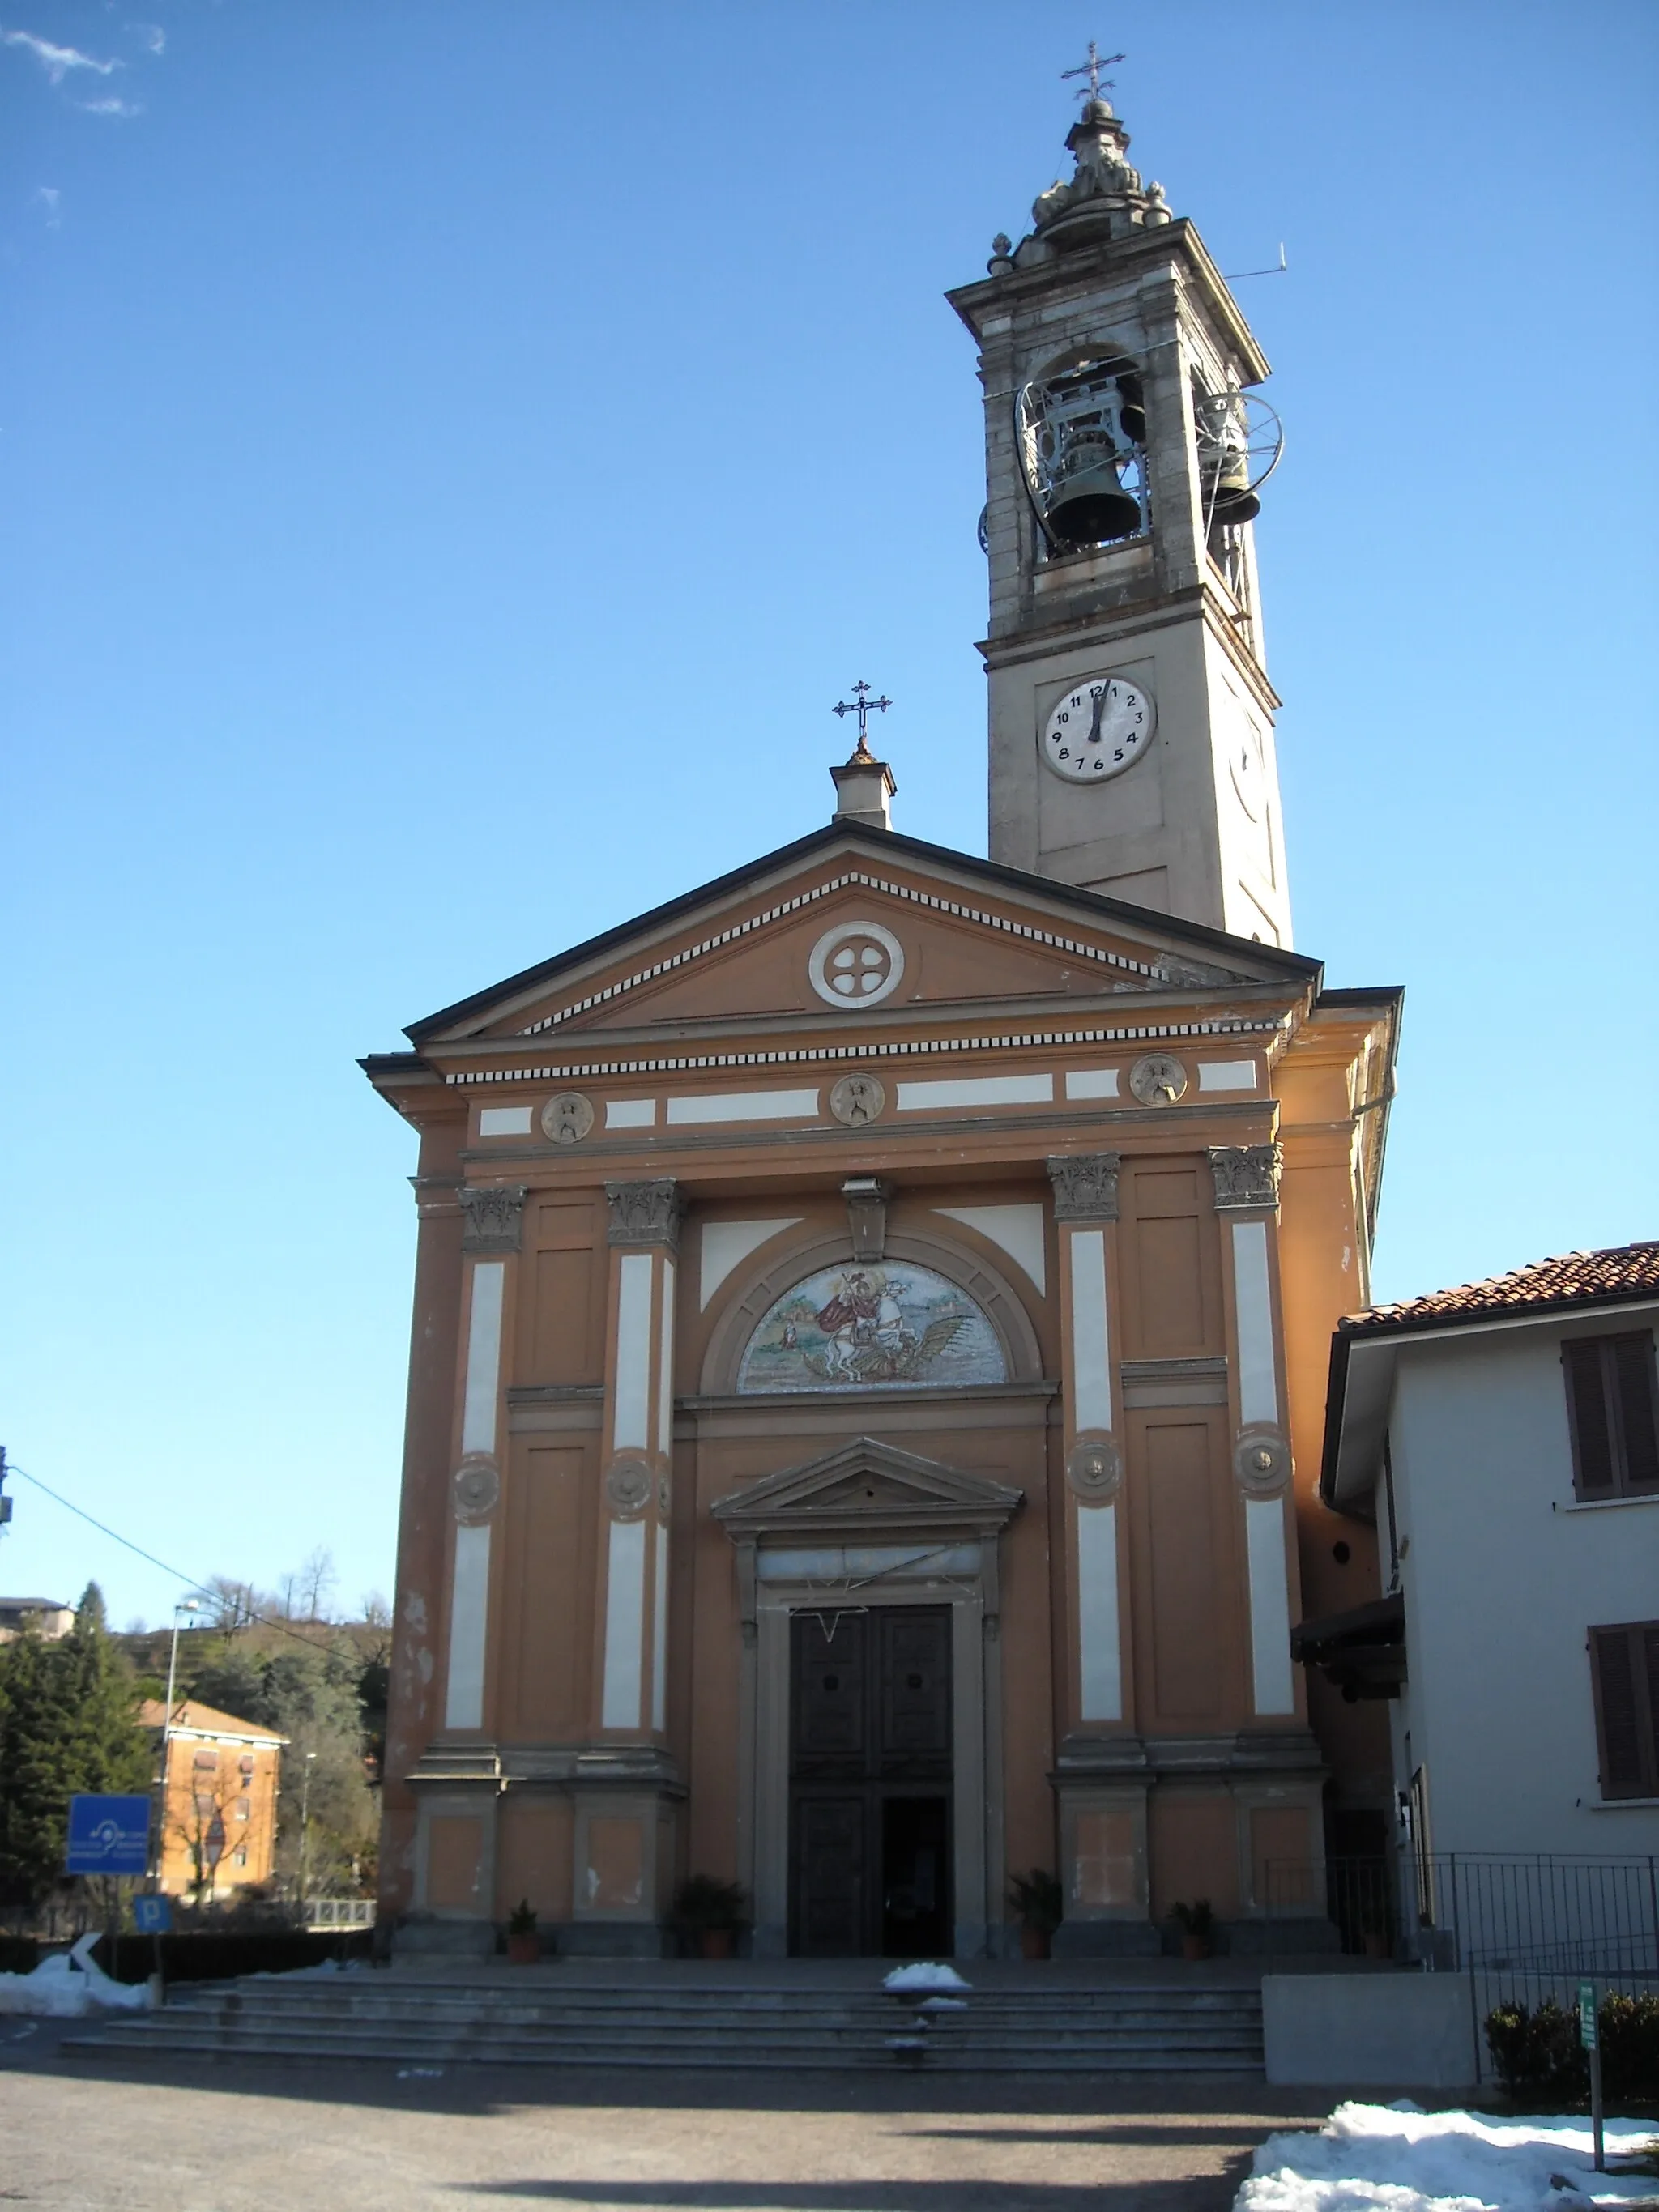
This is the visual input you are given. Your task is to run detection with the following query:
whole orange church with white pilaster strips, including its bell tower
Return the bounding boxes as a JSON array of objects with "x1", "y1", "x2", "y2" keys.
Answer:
[{"x1": 365, "y1": 97, "x2": 1401, "y2": 1958}]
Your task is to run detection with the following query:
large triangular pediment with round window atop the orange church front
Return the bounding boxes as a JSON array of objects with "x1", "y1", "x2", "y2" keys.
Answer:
[{"x1": 409, "y1": 823, "x2": 1318, "y2": 1046}]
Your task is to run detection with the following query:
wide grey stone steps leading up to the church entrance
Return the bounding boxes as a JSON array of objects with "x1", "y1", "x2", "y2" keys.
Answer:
[{"x1": 62, "y1": 1973, "x2": 1263, "y2": 2073}]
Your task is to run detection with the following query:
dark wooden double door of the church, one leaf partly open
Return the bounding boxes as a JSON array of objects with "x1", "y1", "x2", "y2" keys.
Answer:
[{"x1": 790, "y1": 1606, "x2": 953, "y2": 1958}]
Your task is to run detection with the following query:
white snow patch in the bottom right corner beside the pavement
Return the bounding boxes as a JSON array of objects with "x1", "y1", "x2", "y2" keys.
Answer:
[{"x1": 1235, "y1": 2101, "x2": 1653, "y2": 2212}]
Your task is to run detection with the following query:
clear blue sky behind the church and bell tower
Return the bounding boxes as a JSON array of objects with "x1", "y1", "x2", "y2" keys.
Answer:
[{"x1": 0, "y1": 0, "x2": 1659, "y2": 1619}]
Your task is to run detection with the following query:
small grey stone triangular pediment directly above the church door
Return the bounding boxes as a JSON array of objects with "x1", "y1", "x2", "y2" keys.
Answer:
[{"x1": 712, "y1": 1435, "x2": 1024, "y2": 1537}]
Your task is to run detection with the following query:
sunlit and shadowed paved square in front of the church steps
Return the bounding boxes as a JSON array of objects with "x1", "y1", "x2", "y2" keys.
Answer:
[{"x1": 0, "y1": 2019, "x2": 1332, "y2": 2212}]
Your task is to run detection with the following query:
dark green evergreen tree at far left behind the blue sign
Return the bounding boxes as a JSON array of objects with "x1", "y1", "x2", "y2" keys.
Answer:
[{"x1": 0, "y1": 1582, "x2": 155, "y2": 1904}]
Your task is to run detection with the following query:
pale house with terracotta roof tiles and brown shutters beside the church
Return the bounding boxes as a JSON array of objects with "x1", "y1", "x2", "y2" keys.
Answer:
[{"x1": 1299, "y1": 1243, "x2": 1659, "y2": 1860}]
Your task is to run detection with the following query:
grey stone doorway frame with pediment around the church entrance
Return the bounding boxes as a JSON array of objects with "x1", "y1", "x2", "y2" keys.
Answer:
[{"x1": 712, "y1": 1435, "x2": 1024, "y2": 1958}]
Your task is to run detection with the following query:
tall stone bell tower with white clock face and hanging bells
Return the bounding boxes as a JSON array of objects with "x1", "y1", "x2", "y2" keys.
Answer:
[{"x1": 949, "y1": 75, "x2": 1290, "y2": 947}]
